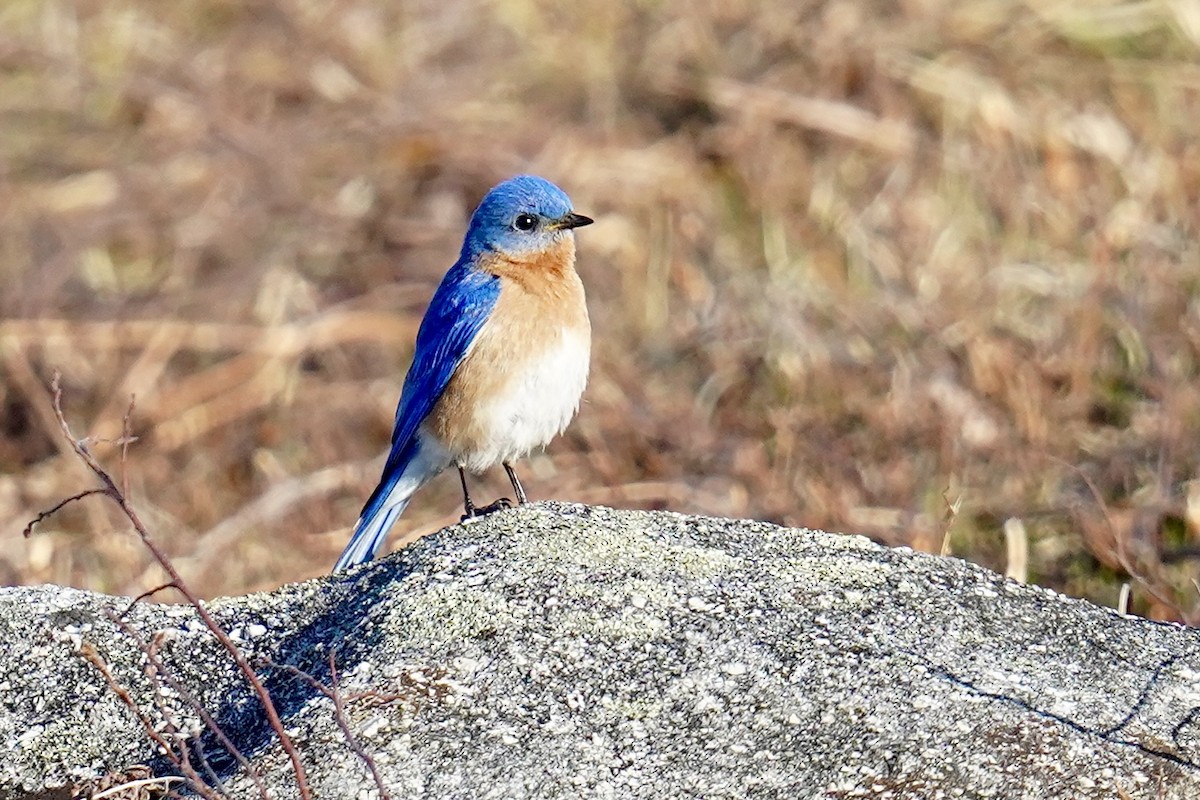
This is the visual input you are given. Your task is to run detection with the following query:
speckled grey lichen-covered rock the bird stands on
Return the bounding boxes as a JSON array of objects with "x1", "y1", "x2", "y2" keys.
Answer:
[{"x1": 0, "y1": 504, "x2": 1200, "y2": 800}]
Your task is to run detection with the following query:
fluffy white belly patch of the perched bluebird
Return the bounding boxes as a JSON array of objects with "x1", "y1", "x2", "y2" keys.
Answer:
[{"x1": 462, "y1": 330, "x2": 590, "y2": 473}]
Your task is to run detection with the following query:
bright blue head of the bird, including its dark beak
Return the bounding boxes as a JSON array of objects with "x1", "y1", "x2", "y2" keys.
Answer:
[{"x1": 462, "y1": 175, "x2": 592, "y2": 259}]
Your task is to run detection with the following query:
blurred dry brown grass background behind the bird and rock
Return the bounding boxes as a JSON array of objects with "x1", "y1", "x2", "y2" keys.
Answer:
[{"x1": 0, "y1": 0, "x2": 1200, "y2": 622}]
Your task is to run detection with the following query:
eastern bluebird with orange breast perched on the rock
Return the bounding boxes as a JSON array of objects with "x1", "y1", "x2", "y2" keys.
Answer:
[{"x1": 334, "y1": 175, "x2": 592, "y2": 572}]
